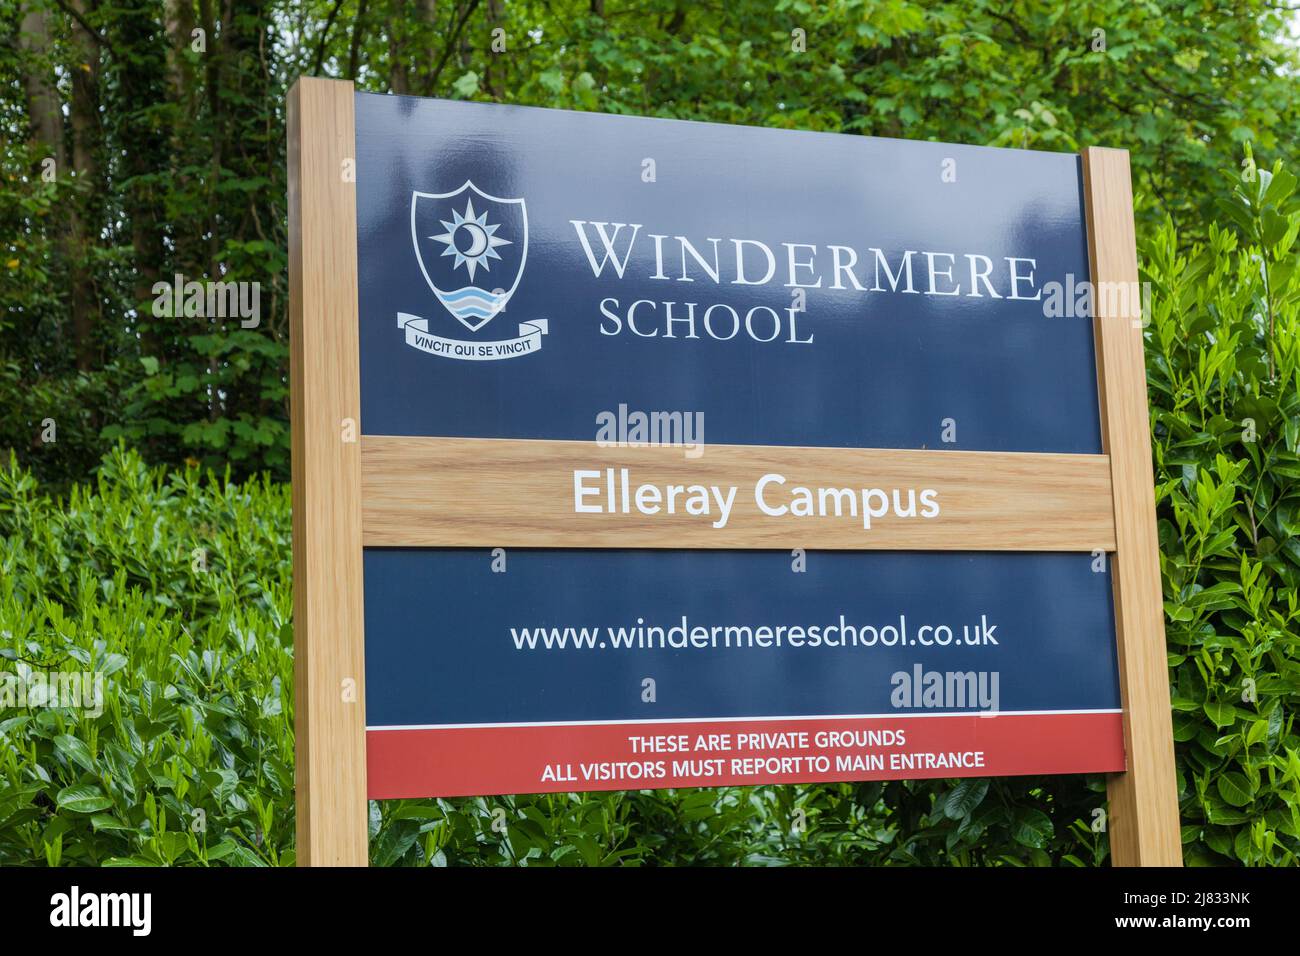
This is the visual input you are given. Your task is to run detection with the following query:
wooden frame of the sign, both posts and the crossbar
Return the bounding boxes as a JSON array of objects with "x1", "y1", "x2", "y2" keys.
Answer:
[{"x1": 289, "y1": 78, "x2": 1182, "y2": 866}]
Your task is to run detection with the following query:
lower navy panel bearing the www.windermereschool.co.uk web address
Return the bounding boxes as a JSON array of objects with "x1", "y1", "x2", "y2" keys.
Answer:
[{"x1": 365, "y1": 549, "x2": 1119, "y2": 727}]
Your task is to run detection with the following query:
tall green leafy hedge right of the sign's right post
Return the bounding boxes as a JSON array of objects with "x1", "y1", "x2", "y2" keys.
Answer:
[{"x1": 1143, "y1": 150, "x2": 1300, "y2": 865}]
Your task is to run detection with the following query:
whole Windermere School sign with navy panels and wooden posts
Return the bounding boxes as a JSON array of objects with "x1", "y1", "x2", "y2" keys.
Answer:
[{"x1": 290, "y1": 81, "x2": 1178, "y2": 862}]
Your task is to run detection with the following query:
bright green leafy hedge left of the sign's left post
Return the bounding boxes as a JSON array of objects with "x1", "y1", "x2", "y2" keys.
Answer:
[{"x1": 0, "y1": 451, "x2": 294, "y2": 865}]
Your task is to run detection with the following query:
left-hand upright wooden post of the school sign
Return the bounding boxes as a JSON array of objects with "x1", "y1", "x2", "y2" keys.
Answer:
[{"x1": 289, "y1": 78, "x2": 368, "y2": 866}]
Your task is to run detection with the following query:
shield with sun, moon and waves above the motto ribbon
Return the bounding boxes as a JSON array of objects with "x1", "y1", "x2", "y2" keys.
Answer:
[{"x1": 411, "y1": 181, "x2": 528, "y2": 332}]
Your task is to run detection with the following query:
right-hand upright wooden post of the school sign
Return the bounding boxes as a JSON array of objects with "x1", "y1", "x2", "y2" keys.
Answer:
[{"x1": 1083, "y1": 148, "x2": 1183, "y2": 866}]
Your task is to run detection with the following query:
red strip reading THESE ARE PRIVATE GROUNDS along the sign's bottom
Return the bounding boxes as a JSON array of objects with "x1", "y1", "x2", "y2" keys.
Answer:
[{"x1": 365, "y1": 711, "x2": 1125, "y2": 800}]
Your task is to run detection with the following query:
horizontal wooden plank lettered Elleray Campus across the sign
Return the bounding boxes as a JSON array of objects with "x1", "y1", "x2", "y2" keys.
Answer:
[{"x1": 361, "y1": 434, "x2": 1115, "y2": 551}]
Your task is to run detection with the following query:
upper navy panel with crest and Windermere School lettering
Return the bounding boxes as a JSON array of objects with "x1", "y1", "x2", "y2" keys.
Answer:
[{"x1": 356, "y1": 94, "x2": 1101, "y2": 453}]
